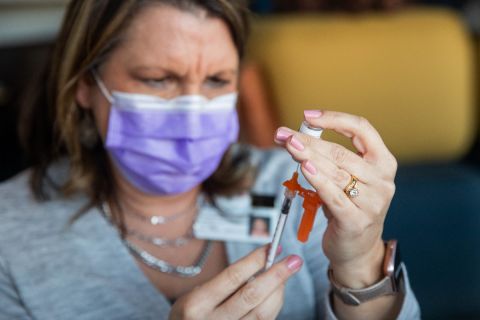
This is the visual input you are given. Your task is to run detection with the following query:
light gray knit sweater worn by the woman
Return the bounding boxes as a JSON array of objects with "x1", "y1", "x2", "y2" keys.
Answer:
[{"x1": 0, "y1": 150, "x2": 420, "y2": 320}]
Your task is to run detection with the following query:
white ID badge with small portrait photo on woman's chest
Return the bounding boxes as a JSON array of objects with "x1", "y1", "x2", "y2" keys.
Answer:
[{"x1": 193, "y1": 194, "x2": 280, "y2": 244}]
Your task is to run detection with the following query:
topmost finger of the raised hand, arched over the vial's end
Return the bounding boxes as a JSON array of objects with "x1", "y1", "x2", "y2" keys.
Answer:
[{"x1": 305, "y1": 111, "x2": 393, "y2": 162}]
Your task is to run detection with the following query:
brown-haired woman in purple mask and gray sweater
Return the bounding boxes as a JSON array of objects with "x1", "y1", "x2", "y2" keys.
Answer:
[{"x1": 0, "y1": 0, "x2": 418, "y2": 319}]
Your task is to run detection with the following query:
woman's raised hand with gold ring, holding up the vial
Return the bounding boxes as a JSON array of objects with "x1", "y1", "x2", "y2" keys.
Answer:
[{"x1": 275, "y1": 110, "x2": 397, "y2": 288}]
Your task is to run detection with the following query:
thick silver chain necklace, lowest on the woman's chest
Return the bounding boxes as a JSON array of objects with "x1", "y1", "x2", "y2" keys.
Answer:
[{"x1": 101, "y1": 202, "x2": 213, "y2": 278}]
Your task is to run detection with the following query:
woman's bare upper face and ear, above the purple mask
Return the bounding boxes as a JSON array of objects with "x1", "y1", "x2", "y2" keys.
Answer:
[{"x1": 76, "y1": 5, "x2": 239, "y2": 139}]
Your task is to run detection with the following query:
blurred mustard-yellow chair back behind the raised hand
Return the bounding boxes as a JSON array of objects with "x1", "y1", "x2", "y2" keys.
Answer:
[{"x1": 248, "y1": 8, "x2": 476, "y2": 162}]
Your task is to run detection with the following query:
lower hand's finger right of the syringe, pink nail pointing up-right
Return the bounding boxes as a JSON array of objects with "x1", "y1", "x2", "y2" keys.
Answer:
[{"x1": 214, "y1": 255, "x2": 303, "y2": 319}]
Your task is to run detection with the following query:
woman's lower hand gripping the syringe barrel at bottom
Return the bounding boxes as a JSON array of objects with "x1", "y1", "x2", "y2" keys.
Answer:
[{"x1": 169, "y1": 246, "x2": 303, "y2": 320}]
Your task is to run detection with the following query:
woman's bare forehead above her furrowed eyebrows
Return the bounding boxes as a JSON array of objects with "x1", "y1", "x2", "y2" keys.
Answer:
[{"x1": 115, "y1": 4, "x2": 238, "y2": 68}]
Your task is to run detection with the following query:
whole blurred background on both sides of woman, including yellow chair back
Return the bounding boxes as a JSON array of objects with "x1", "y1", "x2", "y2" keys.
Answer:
[{"x1": 0, "y1": 0, "x2": 480, "y2": 319}]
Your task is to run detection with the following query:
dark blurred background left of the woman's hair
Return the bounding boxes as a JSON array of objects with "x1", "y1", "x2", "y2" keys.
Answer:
[{"x1": 0, "y1": 0, "x2": 67, "y2": 180}]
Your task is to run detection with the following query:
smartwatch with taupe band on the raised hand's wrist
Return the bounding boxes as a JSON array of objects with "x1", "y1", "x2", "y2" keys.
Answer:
[{"x1": 328, "y1": 240, "x2": 405, "y2": 306}]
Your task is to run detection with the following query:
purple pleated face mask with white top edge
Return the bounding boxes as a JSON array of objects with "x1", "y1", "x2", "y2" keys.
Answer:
[{"x1": 95, "y1": 75, "x2": 239, "y2": 195}]
